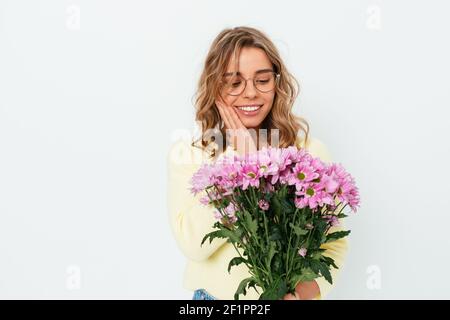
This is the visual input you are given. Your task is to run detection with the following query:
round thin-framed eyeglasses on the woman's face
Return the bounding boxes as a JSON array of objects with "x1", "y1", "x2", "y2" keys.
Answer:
[{"x1": 222, "y1": 71, "x2": 280, "y2": 96}]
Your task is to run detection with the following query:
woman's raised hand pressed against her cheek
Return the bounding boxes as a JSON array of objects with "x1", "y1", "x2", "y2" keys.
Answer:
[{"x1": 216, "y1": 100, "x2": 257, "y2": 155}]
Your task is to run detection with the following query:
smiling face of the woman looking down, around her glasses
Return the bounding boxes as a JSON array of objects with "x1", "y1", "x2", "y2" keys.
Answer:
[{"x1": 217, "y1": 47, "x2": 275, "y2": 129}]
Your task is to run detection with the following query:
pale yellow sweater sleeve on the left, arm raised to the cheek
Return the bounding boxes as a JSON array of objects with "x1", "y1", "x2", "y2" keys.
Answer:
[{"x1": 167, "y1": 140, "x2": 226, "y2": 261}]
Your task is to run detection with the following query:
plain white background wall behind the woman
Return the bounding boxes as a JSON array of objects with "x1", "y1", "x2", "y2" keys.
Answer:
[{"x1": 0, "y1": 0, "x2": 450, "y2": 299}]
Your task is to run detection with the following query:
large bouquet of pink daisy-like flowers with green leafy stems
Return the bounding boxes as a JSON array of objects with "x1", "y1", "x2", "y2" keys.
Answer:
[{"x1": 191, "y1": 146, "x2": 359, "y2": 300}]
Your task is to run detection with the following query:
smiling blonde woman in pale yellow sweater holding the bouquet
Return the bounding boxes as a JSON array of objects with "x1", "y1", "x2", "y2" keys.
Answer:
[{"x1": 168, "y1": 27, "x2": 347, "y2": 300}]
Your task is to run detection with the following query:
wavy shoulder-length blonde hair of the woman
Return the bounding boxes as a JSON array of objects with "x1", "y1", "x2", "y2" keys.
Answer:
[{"x1": 192, "y1": 26, "x2": 309, "y2": 157}]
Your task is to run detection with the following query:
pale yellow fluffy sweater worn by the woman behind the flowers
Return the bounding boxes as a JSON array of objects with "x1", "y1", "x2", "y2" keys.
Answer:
[{"x1": 167, "y1": 138, "x2": 348, "y2": 300}]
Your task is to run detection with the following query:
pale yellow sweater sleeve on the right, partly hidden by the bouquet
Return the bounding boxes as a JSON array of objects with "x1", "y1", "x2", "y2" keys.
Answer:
[{"x1": 308, "y1": 139, "x2": 348, "y2": 299}]
